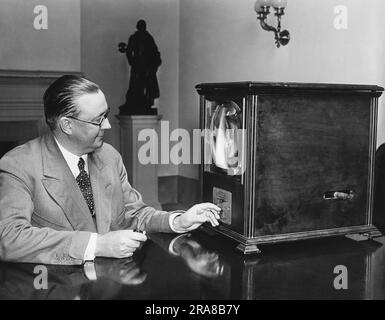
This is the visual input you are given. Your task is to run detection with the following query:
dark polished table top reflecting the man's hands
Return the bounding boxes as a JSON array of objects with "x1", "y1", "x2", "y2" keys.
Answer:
[{"x1": 0, "y1": 230, "x2": 385, "y2": 300}]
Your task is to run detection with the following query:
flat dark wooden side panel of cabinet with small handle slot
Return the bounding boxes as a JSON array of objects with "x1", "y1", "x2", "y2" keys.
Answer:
[{"x1": 254, "y1": 95, "x2": 370, "y2": 236}]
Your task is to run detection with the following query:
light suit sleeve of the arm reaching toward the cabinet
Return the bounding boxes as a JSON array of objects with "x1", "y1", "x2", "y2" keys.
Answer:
[{"x1": 113, "y1": 154, "x2": 184, "y2": 232}]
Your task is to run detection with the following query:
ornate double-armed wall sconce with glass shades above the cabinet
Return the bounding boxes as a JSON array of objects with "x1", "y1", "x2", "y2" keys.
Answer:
[{"x1": 254, "y1": 0, "x2": 290, "y2": 48}]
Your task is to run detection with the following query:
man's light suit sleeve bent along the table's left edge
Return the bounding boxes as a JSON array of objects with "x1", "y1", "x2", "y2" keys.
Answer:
[{"x1": 0, "y1": 156, "x2": 91, "y2": 265}]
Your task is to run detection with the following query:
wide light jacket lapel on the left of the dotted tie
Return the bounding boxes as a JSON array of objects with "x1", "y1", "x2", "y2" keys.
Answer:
[{"x1": 42, "y1": 133, "x2": 97, "y2": 232}]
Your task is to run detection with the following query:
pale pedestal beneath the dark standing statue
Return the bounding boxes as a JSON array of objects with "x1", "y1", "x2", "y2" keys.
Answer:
[{"x1": 116, "y1": 115, "x2": 162, "y2": 209}]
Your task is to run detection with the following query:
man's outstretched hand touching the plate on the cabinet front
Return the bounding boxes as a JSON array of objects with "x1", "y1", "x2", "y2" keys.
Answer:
[{"x1": 174, "y1": 202, "x2": 221, "y2": 231}]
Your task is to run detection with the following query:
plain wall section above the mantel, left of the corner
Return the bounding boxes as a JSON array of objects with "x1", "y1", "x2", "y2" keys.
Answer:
[{"x1": 0, "y1": 0, "x2": 80, "y2": 71}]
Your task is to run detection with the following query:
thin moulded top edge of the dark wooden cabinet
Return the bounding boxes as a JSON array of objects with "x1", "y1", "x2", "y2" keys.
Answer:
[{"x1": 195, "y1": 81, "x2": 384, "y2": 94}]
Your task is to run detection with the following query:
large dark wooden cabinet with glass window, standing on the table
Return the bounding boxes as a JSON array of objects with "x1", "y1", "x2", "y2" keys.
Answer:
[{"x1": 197, "y1": 82, "x2": 383, "y2": 253}]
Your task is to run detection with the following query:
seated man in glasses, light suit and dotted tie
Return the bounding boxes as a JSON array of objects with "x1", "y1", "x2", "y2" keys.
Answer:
[{"x1": 0, "y1": 75, "x2": 220, "y2": 265}]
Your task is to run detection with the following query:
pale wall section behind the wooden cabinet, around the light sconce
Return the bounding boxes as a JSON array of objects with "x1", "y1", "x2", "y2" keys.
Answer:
[{"x1": 179, "y1": 0, "x2": 385, "y2": 178}]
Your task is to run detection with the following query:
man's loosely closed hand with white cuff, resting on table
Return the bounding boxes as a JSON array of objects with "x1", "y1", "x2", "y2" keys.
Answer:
[{"x1": 95, "y1": 230, "x2": 147, "y2": 258}]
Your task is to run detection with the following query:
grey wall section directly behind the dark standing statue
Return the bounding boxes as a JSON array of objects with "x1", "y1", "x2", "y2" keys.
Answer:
[{"x1": 81, "y1": 0, "x2": 179, "y2": 176}]
